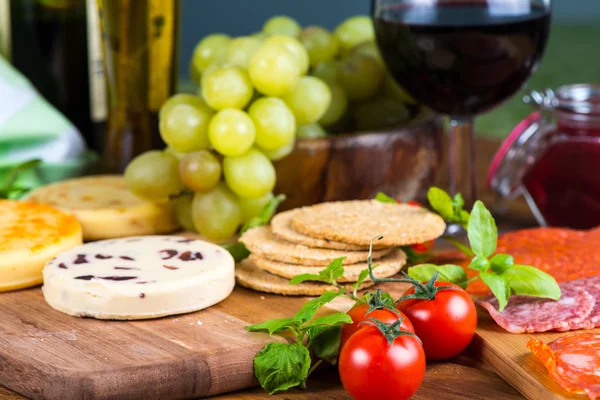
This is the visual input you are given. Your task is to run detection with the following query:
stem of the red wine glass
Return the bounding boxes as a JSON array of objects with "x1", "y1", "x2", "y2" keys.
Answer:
[{"x1": 448, "y1": 118, "x2": 477, "y2": 208}]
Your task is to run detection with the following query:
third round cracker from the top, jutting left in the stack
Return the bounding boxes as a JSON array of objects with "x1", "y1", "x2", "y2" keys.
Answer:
[{"x1": 240, "y1": 226, "x2": 392, "y2": 266}]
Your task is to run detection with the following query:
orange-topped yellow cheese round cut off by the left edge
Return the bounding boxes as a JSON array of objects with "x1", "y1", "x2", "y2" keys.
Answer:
[{"x1": 0, "y1": 200, "x2": 81, "y2": 292}]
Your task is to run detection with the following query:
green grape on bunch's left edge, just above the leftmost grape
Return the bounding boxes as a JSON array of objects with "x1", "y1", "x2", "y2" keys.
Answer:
[{"x1": 158, "y1": 103, "x2": 213, "y2": 153}]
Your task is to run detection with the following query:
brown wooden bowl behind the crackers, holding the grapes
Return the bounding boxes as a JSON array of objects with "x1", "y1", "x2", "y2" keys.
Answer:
[{"x1": 275, "y1": 109, "x2": 443, "y2": 210}]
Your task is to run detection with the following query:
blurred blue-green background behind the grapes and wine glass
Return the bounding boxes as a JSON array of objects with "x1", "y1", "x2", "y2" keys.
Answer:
[{"x1": 180, "y1": 0, "x2": 600, "y2": 138}]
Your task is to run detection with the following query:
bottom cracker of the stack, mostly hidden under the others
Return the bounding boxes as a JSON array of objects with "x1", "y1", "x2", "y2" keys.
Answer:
[{"x1": 235, "y1": 259, "x2": 374, "y2": 296}]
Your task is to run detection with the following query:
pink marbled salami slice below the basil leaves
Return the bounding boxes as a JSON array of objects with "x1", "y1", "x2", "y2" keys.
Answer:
[{"x1": 477, "y1": 285, "x2": 596, "y2": 333}]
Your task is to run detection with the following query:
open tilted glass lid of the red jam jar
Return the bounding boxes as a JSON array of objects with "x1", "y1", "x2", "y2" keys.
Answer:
[{"x1": 487, "y1": 112, "x2": 552, "y2": 198}]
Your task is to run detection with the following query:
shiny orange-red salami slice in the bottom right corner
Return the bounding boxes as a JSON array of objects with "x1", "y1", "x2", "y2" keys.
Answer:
[{"x1": 527, "y1": 333, "x2": 600, "y2": 400}]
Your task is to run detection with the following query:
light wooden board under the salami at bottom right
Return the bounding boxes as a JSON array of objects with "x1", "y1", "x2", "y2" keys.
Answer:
[{"x1": 471, "y1": 310, "x2": 600, "y2": 400}]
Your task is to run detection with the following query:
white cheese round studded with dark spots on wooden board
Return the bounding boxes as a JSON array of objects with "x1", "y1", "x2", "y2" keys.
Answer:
[{"x1": 42, "y1": 236, "x2": 235, "y2": 319}]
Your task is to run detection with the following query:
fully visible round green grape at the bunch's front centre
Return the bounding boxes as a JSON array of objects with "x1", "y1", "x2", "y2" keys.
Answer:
[{"x1": 208, "y1": 108, "x2": 256, "y2": 156}]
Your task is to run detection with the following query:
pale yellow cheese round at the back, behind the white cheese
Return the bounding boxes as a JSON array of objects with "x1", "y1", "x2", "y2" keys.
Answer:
[{"x1": 27, "y1": 175, "x2": 178, "y2": 241}]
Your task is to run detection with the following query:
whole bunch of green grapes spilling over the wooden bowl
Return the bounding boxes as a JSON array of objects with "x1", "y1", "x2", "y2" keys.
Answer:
[{"x1": 125, "y1": 16, "x2": 414, "y2": 240}]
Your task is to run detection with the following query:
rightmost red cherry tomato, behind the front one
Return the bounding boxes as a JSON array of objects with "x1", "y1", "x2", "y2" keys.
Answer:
[{"x1": 396, "y1": 281, "x2": 477, "y2": 360}]
